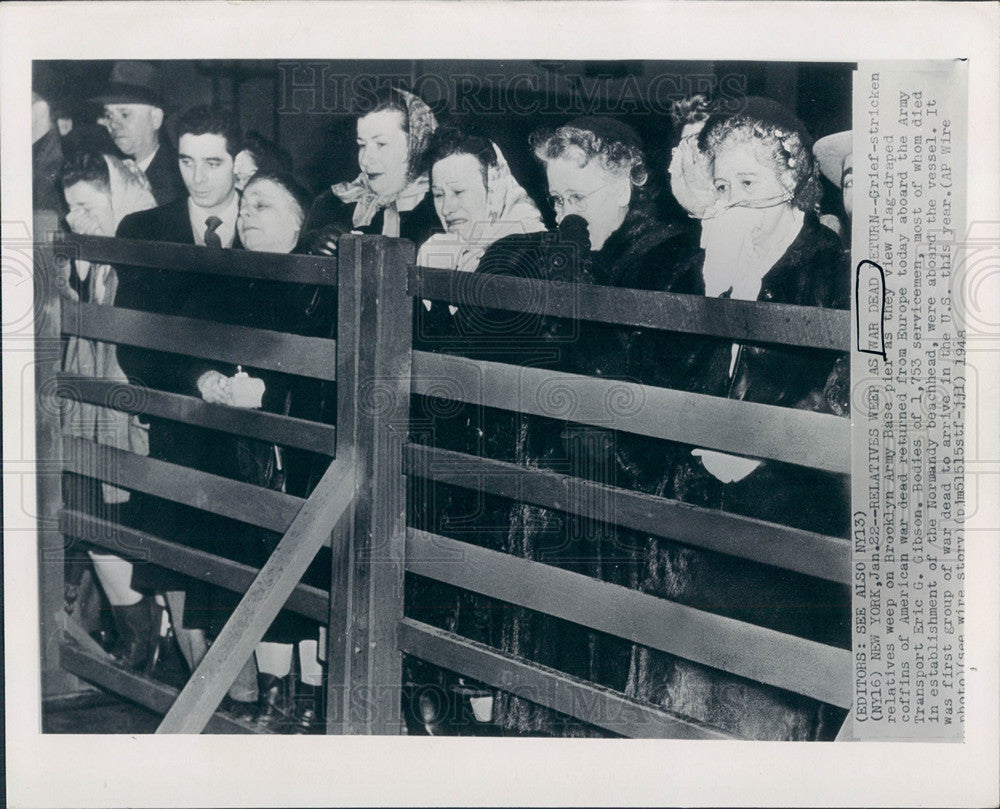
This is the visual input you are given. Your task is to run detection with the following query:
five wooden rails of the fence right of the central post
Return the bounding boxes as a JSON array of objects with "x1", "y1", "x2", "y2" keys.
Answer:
[{"x1": 400, "y1": 267, "x2": 852, "y2": 738}]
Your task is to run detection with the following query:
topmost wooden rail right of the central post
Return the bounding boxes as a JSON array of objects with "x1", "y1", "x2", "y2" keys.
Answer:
[{"x1": 410, "y1": 267, "x2": 851, "y2": 351}]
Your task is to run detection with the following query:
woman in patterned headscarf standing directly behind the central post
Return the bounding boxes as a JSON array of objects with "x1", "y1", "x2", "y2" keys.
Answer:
[{"x1": 304, "y1": 88, "x2": 437, "y2": 255}]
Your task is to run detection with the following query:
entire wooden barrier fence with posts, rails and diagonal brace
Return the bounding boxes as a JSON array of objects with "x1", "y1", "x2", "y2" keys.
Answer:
[{"x1": 36, "y1": 230, "x2": 851, "y2": 738}]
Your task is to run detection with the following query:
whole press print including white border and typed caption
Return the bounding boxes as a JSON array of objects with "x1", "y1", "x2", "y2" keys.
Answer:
[{"x1": 4, "y1": 3, "x2": 1000, "y2": 805}]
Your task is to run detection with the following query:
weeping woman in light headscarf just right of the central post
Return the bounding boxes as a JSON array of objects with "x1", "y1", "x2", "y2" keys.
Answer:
[{"x1": 406, "y1": 127, "x2": 545, "y2": 732}]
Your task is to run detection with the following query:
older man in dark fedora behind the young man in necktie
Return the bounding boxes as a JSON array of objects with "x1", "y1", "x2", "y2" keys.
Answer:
[{"x1": 93, "y1": 61, "x2": 184, "y2": 205}]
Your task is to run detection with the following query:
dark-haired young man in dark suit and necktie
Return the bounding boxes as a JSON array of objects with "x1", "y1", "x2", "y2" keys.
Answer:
[{"x1": 115, "y1": 107, "x2": 241, "y2": 669}]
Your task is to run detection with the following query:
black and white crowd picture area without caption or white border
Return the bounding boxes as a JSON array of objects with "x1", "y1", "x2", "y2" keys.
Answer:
[{"x1": 32, "y1": 52, "x2": 851, "y2": 741}]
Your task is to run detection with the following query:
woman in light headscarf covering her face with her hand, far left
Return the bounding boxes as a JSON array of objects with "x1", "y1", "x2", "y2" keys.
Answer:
[{"x1": 61, "y1": 153, "x2": 160, "y2": 668}]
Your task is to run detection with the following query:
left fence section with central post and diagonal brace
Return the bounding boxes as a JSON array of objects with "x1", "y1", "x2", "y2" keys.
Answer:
[{"x1": 36, "y1": 236, "x2": 413, "y2": 733}]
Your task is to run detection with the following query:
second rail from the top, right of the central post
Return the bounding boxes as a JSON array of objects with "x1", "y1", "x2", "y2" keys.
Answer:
[{"x1": 412, "y1": 351, "x2": 851, "y2": 474}]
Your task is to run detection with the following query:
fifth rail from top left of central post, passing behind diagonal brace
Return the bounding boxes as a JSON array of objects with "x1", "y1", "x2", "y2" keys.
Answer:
[{"x1": 59, "y1": 509, "x2": 330, "y2": 624}]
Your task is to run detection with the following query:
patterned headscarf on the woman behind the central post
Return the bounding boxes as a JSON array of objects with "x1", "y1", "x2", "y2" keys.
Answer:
[{"x1": 331, "y1": 87, "x2": 437, "y2": 236}]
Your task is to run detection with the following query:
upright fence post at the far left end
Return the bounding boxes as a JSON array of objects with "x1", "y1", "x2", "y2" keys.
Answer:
[{"x1": 32, "y1": 219, "x2": 84, "y2": 697}]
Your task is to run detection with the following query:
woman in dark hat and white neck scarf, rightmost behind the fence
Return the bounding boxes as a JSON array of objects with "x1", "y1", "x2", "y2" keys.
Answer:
[{"x1": 608, "y1": 98, "x2": 850, "y2": 740}]
